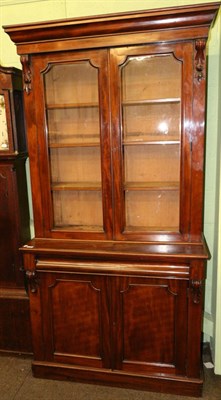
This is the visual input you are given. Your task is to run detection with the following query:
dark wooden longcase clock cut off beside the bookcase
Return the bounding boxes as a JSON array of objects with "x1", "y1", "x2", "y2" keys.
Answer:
[{"x1": 0, "y1": 66, "x2": 32, "y2": 353}]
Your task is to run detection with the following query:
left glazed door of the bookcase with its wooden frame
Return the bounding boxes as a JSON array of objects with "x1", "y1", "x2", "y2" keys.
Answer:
[{"x1": 30, "y1": 51, "x2": 112, "y2": 239}]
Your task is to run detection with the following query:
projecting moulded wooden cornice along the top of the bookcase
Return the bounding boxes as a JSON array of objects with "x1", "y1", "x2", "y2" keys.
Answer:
[{"x1": 4, "y1": 2, "x2": 221, "y2": 44}]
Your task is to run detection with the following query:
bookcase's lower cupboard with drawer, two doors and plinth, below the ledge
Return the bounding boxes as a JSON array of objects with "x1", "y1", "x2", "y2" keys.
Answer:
[{"x1": 23, "y1": 255, "x2": 205, "y2": 396}]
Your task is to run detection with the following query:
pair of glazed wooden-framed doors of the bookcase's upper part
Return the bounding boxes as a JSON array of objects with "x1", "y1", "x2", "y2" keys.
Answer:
[{"x1": 26, "y1": 43, "x2": 193, "y2": 241}]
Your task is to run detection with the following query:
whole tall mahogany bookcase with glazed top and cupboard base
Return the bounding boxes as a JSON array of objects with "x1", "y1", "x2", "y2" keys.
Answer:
[{"x1": 5, "y1": 3, "x2": 219, "y2": 396}]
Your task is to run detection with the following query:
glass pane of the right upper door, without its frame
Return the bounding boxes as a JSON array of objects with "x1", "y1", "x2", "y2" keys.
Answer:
[{"x1": 121, "y1": 55, "x2": 181, "y2": 231}]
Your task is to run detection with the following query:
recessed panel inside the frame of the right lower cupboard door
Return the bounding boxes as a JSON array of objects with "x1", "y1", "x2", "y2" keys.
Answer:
[{"x1": 123, "y1": 284, "x2": 176, "y2": 364}]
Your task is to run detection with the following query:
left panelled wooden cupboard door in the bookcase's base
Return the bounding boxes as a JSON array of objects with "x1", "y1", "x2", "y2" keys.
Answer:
[{"x1": 37, "y1": 272, "x2": 110, "y2": 368}]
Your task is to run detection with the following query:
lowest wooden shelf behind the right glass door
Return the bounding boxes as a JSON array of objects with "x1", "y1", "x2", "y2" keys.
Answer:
[{"x1": 124, "y1": 182, "x2": 179, "y2": 191}]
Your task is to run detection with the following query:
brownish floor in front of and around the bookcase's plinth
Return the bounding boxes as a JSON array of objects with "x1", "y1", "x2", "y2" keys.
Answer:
[{"x1": 0, "y1": 356, "x2": 221, "y2": 400}]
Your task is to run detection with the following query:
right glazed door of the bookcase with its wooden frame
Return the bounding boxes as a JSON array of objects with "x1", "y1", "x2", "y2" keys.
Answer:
[{"x1": 111, "y1": 44, "x2": 192, "y2": 240}]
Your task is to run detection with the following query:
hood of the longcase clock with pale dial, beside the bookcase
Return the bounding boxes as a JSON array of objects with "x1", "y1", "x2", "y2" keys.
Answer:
[{"x1": 0, "y1": 66, "x2": 26, "y2": 157}]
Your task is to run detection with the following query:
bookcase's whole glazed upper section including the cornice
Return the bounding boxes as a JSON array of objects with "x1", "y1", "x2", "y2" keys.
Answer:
[{"x1": 4, "y1": 3, "x2": 219, "y2": 242}]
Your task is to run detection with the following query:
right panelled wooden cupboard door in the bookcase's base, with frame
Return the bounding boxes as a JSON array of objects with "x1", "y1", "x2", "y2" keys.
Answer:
[{"x1": 113, "y1": 277, "x2": 187, "y2": 375}]
